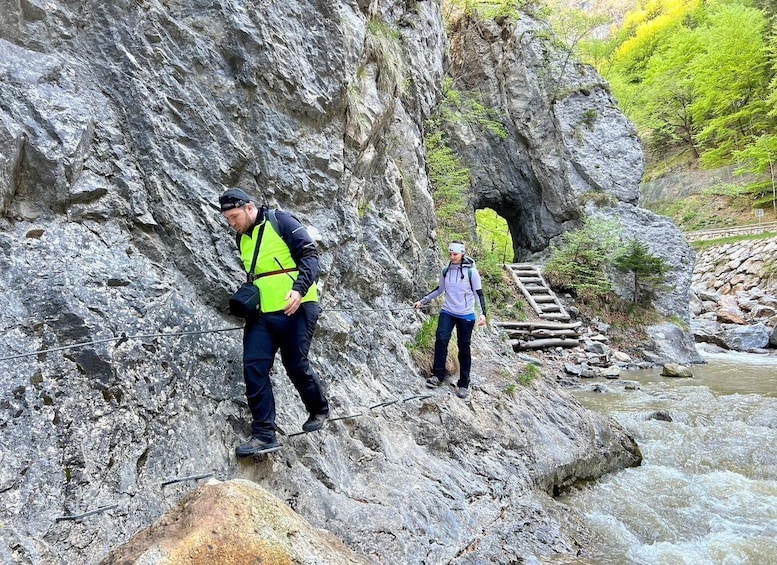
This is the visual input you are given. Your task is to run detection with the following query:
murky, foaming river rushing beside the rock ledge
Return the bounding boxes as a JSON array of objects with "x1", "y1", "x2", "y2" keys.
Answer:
[{"x1": 561, "y1": 353, "x2": 777, "y2": 565}]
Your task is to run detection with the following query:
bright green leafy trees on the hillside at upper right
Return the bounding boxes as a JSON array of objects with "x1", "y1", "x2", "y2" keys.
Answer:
[{"x1": 550, "y1": 0, "x2": 777, "y2": 216}]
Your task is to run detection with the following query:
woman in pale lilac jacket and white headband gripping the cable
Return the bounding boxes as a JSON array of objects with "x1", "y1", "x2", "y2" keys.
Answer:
[{"x1": 413, "y1": 241, "x2": 486, "y2": 398}]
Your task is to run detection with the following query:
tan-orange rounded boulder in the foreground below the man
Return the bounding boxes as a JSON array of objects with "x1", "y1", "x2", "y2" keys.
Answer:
[{"x1": 102, "y1": 479, "x2": 370, "y2": 565}]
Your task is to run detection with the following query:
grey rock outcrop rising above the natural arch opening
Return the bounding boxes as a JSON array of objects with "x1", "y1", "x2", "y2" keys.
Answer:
[{"x1": 451, "y1": 14, "x2": 643, "y2": 260}]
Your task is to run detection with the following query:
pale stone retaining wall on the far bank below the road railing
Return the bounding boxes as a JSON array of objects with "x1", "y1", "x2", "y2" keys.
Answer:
[{"x1": 692, "y1": 237, "x2": 777, "y2": 294}]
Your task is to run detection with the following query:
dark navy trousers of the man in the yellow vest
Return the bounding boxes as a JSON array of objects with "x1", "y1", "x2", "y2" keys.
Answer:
[{"x1": 243, "y1": 302, "x2": 329, "y2": 441}]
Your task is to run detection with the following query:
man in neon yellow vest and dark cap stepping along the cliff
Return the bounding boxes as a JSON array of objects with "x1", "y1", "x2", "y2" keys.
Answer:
[{"x1": 219, "y1": 188, "x2": 329, "y2": 457}]
